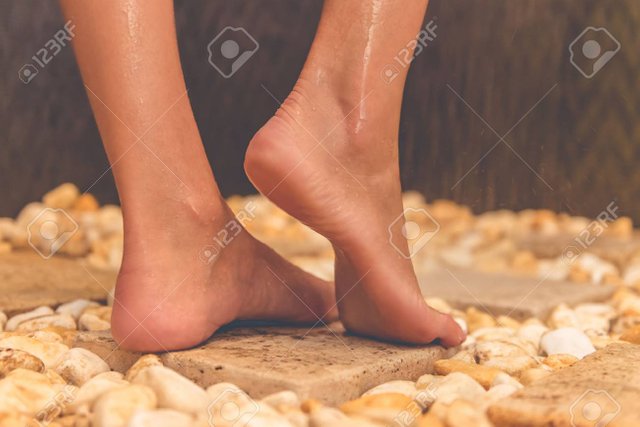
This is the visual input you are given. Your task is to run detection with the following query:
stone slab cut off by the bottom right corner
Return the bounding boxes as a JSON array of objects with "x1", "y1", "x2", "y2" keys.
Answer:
[{"x1": 489, "y1": 343, "x2": 640, "y2": 427}]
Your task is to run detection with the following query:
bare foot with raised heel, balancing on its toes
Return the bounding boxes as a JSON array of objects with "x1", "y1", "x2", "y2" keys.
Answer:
[{"x1": 245, "y1": 78, "x2": 464, "y2": 346}]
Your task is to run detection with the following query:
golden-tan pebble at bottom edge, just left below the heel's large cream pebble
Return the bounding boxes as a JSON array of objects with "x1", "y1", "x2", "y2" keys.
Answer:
[{"x1": 92, "y1": 384, "x2": 156, "y2": 427}]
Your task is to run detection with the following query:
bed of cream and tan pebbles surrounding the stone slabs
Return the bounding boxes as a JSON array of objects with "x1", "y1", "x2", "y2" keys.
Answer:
[{"x1": 0, "y1": 184, "x2": 640, "y2": 427}]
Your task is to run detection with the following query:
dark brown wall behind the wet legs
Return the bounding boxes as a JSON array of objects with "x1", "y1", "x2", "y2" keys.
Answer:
[{"x1": 0, "y1": 0, "x2": 640, "y2": 220}]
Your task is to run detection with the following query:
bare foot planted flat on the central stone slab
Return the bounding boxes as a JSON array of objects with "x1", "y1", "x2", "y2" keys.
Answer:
[{"x1": 111, "y1": 200, "x2": 337, "y2": 351}]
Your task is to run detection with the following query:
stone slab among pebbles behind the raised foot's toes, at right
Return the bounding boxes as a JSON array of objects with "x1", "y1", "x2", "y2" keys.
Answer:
[{"x1": 420, "y1": 269, "x2": 615, "y2": 319}]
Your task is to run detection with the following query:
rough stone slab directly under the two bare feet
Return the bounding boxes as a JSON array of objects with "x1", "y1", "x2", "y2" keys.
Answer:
[{"x1": 75, "y1": 323, "x2": 454, "y2": 404}]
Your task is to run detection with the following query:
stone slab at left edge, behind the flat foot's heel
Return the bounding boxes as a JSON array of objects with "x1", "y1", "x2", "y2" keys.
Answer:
[{"x1": 0, "y1": 251, "x2": 116, "y2": 315}]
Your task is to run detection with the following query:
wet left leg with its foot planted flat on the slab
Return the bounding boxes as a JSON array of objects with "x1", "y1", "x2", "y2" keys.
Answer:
[{"x1": 62, "y1": 0, "x2": 335, "y2": 351}]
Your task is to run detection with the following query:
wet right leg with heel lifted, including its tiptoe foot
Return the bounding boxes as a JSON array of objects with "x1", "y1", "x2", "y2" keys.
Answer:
[{"x1": 245, "y1": 0, "x2": 464, "y2": 345}]
